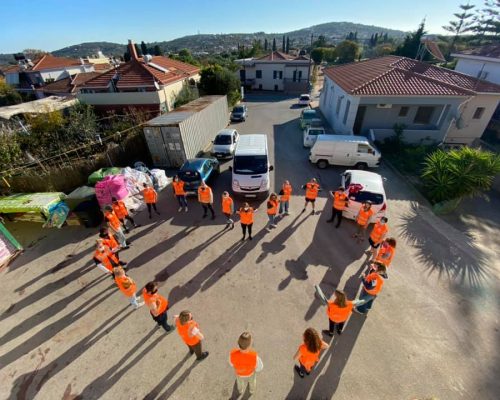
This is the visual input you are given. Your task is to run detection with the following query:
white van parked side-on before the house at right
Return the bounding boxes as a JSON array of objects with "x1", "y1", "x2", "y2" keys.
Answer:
[{"x1": 309, "y1": 135, "x2": 381, "y2": 169}]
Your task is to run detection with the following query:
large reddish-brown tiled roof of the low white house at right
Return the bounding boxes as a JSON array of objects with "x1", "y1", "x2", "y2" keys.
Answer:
[{"x1": 325, "y1": 56, "x2": 500, "y2": 96}]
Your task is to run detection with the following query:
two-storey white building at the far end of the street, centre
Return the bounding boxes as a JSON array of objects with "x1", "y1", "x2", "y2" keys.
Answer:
[{"x1": 236, "y1": 51, "x2": 312, "y2": 93}]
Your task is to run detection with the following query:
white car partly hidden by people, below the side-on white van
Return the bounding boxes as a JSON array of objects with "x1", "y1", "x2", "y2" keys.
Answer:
[{"x1": 341, "y1": 169, "x2": 387, "y2": 223}]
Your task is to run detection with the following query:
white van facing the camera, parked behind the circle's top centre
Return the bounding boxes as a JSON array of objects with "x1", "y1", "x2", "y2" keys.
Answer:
[{"x1": 231, "y1": 134, "x2": 273, "y2": 197}]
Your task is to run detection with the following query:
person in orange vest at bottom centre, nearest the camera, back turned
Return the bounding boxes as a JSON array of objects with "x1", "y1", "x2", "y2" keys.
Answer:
[{"x1": 229, "y1": 332, "x2": 264, "y2": 395}]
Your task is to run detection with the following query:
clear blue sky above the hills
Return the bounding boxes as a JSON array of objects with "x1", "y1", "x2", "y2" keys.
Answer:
[{"x1": 0, "y1": 0, "x2": 483, "y2": 53}]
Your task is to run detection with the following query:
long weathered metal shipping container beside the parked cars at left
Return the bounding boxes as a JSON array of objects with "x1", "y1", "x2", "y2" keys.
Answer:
[{"x1": 144, "y1": 96, "x2": 229, "y2": 168}]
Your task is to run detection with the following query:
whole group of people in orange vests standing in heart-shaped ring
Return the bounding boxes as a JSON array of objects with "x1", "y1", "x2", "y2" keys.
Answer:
[{"x1": 88, "y1": 176, "x2": 396, "y2": 394}]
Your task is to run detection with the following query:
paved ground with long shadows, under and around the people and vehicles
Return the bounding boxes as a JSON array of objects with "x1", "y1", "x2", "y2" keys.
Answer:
[{"x1": 0, "y1": 96, "x2": 500, "y2": 400}]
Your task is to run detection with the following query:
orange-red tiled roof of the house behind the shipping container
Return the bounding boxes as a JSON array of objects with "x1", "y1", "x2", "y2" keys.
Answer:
[{"x1": 80, "y1": 56, "x2": 199, "y2": 88}]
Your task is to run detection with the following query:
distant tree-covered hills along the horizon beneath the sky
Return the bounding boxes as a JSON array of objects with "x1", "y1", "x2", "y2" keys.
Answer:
[{"x1": 0, "y1": 22, "x2": 405, "y2": 64}]
